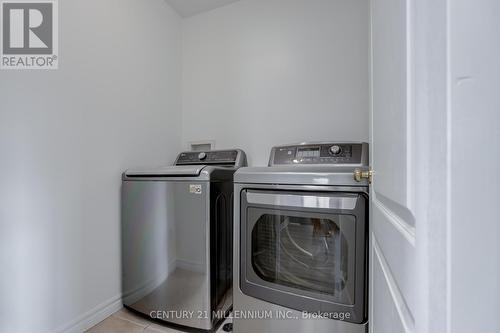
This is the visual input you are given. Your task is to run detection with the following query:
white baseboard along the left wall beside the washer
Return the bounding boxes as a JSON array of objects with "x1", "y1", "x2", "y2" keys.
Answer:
[{"x1": 54, "y1": 295, "x2": 123, "y2": 333}]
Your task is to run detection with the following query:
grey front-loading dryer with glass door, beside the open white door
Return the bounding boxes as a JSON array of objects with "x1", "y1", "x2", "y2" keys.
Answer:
[{"x1": 233, "y1": 142, "x2": 369, "y2": 333}]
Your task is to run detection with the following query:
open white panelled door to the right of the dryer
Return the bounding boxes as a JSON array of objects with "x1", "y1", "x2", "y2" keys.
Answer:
[{"x1": 369, "y1": 0, "x2": 500, "y2": 333}]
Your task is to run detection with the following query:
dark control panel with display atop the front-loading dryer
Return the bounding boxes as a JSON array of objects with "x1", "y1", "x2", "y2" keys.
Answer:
[{"x1": 269, "y1": 142, "x2": 368, "y2": 166}]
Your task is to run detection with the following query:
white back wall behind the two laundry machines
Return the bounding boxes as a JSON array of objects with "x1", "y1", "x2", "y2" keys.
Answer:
[{"x1": 182, "y1": 0, "x2": 369, "y2": 165}]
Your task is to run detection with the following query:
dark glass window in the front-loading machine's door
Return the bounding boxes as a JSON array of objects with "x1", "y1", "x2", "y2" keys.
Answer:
[{"x1": 252, "y1": 212, "x2": 355, "y2": 304}]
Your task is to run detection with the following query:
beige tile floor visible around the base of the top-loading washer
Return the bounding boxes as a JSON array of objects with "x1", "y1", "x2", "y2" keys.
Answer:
[{"x1": 86, "y1": 309, "x2": 231, "y2": 333}]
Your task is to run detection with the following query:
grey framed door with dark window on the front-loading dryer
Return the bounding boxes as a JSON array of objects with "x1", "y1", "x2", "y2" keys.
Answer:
[{"x1": 240, "y1": 190, "x2": 367, "y2": 323}]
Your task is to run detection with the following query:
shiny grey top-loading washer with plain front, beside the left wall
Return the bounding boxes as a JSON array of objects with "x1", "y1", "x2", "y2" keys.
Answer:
[{"x1": 121, "y1": 149, "x2": 247, "y2": 331}]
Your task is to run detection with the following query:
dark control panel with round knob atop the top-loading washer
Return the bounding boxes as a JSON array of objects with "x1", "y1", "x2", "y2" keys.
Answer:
[{"x1": 175, "y1": 149, "x2": 246, "y2": 166}]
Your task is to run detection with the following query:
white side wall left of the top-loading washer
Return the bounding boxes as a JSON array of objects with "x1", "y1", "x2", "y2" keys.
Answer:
[{"x1": 0, "y1": 0, "x2": 181, "y2": 333}]
